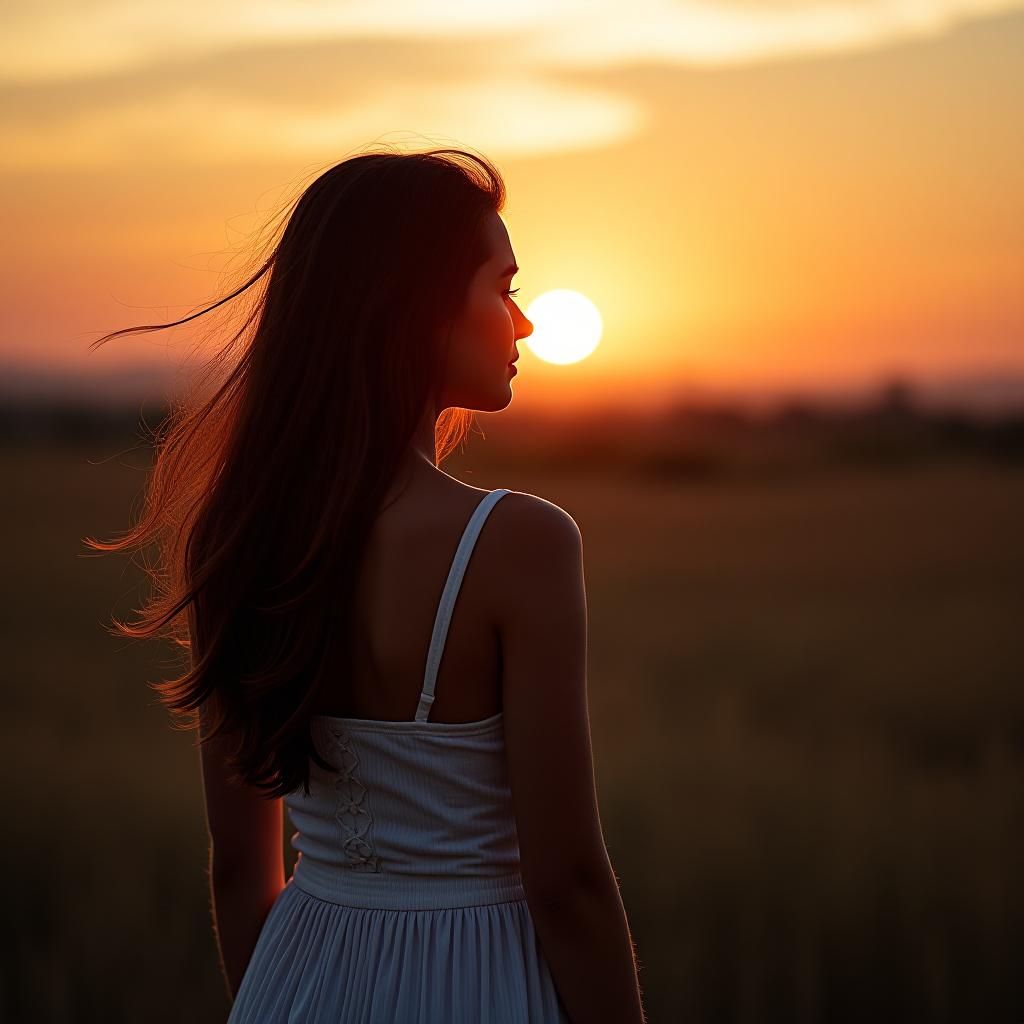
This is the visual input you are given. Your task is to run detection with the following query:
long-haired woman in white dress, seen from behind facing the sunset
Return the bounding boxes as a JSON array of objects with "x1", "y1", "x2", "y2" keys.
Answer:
[{"x1": 90, "y1": 150, "x2": 644, "y2": 1024}]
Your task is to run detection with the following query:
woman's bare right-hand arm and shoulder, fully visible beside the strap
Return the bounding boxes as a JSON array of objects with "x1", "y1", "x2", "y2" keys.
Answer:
[{"x1": 494, "y1": 493, "x2": 644, "y2": 1024}]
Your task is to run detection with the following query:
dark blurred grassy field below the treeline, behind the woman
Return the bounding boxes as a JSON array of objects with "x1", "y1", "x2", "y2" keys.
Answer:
[{"x1": 0, "y1": 439, "x2": 1024, "y2": 1024}]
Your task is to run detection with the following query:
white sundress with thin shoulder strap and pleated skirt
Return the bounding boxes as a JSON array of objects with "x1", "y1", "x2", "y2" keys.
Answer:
[{"x1": 228, "y1": 487, "x2": 569, "y2": 1024}]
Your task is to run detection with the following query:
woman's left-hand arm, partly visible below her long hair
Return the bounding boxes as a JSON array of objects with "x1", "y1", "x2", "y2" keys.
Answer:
[{"x1": 200, "y1": 710, "x2": 285, "y2": 999}]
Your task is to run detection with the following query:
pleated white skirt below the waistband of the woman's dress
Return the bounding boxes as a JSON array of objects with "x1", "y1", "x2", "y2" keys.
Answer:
[{"x1": 228, "y1": 876, "x2": 569, "y2": 1024}]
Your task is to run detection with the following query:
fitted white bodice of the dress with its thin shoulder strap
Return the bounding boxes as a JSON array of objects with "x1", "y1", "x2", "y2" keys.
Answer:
[{"x1": 285, "y1": 488, "x2": 524, "y2": 910}]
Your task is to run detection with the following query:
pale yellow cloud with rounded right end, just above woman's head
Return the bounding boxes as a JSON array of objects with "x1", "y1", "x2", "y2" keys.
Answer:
[{"x1": 0, "y1": 38, "x2": 645, "y2": 170}]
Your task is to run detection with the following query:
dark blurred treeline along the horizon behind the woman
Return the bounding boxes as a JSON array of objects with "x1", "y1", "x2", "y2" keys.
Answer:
[{"x1": 0, "y1": 386, "x2": 1024, "y2": 480}]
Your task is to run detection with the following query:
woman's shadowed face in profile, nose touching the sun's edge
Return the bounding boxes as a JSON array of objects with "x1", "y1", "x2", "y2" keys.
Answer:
[{"x1": 441, "y1": 211, "x2": 534, "y2": 413}]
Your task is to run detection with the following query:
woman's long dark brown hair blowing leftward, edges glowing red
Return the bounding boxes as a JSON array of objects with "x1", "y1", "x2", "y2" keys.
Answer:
[{"x1": 83, "y1": 150, "x2": 506, "y2": 799}]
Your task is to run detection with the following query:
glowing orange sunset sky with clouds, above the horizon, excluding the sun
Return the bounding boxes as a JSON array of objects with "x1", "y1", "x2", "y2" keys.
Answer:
[{"x1": 0, "y1": 0, "x2": 1024, "y2": 404}]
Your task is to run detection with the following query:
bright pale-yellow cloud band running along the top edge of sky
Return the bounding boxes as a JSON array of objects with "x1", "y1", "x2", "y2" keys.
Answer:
[{"x1": 6, "y1": 0, "x2": 1024, "y2": 82}]
